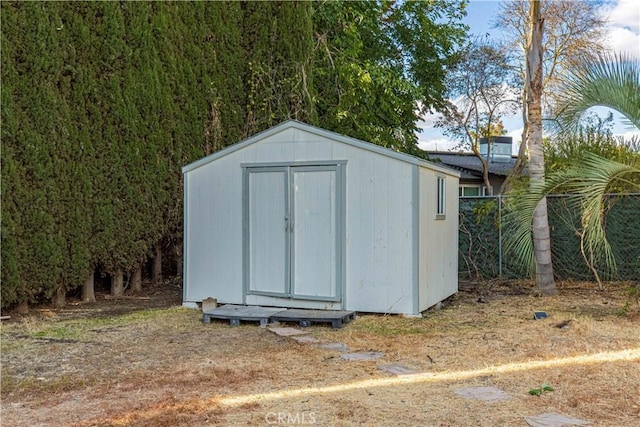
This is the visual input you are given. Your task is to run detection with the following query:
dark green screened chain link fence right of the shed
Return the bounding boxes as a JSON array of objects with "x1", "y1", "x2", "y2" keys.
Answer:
[{"x1": 458, "y1": 194, "x2": 640, "y2": 280}]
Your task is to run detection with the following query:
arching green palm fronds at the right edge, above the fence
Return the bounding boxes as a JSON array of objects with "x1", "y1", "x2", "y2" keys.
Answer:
[{"x1": 506, "y1": 54, "x2": 640, "y2": 284}]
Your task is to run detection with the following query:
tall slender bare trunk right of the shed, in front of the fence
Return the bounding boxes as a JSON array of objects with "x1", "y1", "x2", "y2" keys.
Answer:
[{"x1": 526, "y1": 0, "x2": 557, "y2": 295}]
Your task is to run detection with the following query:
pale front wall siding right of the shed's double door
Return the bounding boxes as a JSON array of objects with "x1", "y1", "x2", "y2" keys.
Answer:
[{"x1": 334, "y1": 144, "x2": 415, "y2": 313}]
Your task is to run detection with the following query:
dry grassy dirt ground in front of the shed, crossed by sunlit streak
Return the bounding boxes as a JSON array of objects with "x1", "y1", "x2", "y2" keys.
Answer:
[{"x1": 0, "y1": 282, "x2": 640, "y2": 427}]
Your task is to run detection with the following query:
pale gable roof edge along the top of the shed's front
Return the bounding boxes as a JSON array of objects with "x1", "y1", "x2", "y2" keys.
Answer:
[{"x1": 182, "y1": 120, "x2": 460, "y2": 176}]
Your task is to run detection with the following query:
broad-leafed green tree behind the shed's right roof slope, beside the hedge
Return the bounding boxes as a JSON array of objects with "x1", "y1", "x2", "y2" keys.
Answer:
[{"x1": 313, "y1": 1, "x2": 466, "y2": 154}]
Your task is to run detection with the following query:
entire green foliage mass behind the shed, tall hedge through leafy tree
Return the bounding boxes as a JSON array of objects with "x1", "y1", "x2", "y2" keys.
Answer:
[{"x1": 0, "y1": 0, "x2": 465, "y2": 307}]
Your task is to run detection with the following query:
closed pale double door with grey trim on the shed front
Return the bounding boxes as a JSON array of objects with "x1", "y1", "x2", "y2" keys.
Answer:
[{"x1": 245, "y1": 165, "x2": 342, "y2": 301}]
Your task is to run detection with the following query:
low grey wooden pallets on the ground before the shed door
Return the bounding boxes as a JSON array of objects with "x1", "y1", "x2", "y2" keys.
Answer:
[{"x1": 202, "y1": 304, "x2": 356, "y2": 329}]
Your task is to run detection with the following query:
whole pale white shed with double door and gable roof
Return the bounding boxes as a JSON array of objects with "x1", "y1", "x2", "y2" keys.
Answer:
[{"x1": 183, "y1": 121, "x2": 459, "y2": 315}]
